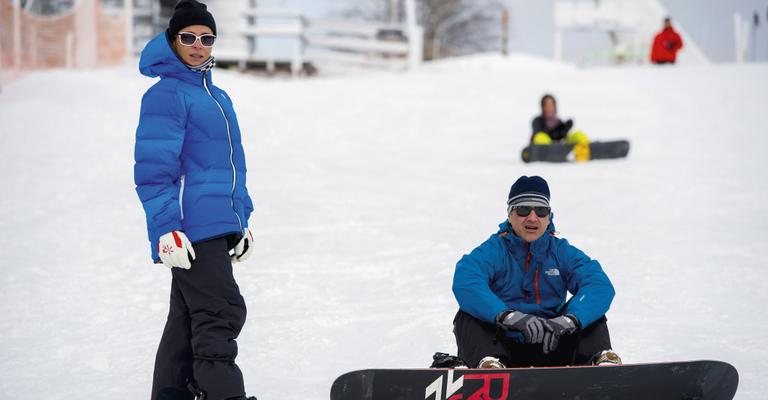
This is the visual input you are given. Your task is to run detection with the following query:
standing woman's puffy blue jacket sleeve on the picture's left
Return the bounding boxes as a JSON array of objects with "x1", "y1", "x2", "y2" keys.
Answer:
[{"x1": 133, "y1": 85, "x2": 186, "y2": 239}]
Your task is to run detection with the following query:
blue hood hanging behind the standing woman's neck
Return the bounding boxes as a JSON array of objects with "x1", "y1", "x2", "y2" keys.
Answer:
[{"x1": 139, "y1": 31, "x2": 210, "y2": 82}]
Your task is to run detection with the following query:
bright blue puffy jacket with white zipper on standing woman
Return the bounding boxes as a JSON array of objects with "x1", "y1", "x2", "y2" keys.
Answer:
[{"x1": 134, "y1": 33, "x2": 253, "y2": 262}]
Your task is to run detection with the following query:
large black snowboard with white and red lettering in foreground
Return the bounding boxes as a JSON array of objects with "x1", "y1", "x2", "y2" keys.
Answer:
[{"x1": 331, "y1": 361, "x2": 739, "y2": 400}]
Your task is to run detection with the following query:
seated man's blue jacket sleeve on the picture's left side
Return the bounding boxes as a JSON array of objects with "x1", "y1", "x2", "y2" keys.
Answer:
[{"x1": 453, "y1": 235, "x2": 507, "y2": 323}]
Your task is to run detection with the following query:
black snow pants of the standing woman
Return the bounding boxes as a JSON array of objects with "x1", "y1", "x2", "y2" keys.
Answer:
[{"x1": 152, "y1": 238, "x2": 246, "y2": 400}]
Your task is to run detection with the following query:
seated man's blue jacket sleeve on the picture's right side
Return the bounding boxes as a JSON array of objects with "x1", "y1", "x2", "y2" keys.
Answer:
[{"x1": 558, "y1": 239, "x2": 616, "y2": 327}]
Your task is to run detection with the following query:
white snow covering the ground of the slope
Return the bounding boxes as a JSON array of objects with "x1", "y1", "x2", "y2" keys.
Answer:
[{"x1": 0, "y1": 56, "x2": 768, "y2": 400}]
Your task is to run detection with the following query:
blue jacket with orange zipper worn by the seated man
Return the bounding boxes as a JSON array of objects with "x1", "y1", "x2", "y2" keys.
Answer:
[{"x1": 453, "y1": 217, "x2": 615, "y2": 327}]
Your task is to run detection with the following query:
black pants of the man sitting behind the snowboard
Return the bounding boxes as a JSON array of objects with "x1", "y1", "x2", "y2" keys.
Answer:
[{"x1": 453, "y1": 310, "x2": 611, "y2": 368}]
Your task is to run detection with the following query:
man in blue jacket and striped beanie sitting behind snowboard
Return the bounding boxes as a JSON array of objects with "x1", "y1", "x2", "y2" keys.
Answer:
[{"x1": 453, "y1": 176, "x2": 621, "y2": 368}]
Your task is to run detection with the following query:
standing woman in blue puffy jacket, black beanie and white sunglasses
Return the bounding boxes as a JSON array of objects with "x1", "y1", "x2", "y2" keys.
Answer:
[{"x1": 134, "y1": 0, "x2": 255, "y2": 400}]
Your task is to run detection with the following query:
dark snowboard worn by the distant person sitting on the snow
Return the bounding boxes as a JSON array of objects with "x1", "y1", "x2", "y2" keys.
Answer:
[{"x1": 522, "y1": 140, "x2": 629, "y2": 163}]
